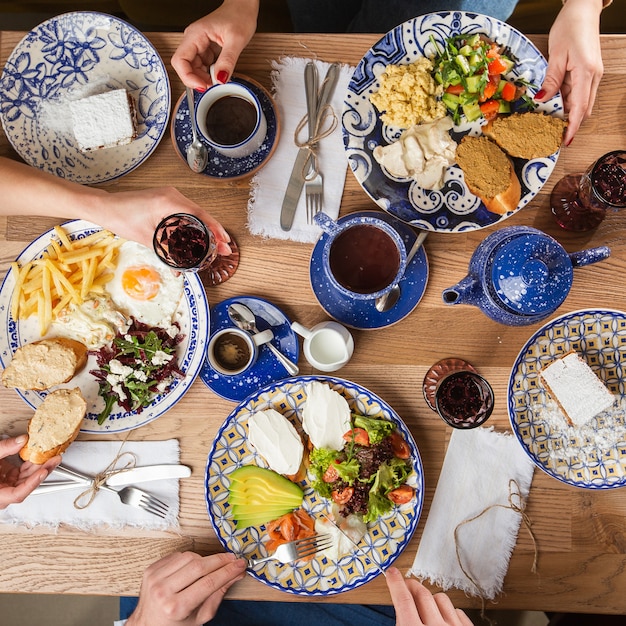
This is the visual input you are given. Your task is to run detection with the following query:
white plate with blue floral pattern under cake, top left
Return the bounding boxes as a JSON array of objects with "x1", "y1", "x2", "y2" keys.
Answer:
[{"x1": 0, "y1": 11, "x2": 171, "y2": 183}]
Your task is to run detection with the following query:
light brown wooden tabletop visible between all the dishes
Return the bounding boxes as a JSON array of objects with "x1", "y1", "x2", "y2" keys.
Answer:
[{"x1": 0, "y1": 32, "x2": 626, "y2": 615}]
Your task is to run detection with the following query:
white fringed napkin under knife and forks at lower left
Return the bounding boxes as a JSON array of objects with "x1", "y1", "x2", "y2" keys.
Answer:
[{"x1": 0, "y1": 439, "x2": 180, "y2": 530}]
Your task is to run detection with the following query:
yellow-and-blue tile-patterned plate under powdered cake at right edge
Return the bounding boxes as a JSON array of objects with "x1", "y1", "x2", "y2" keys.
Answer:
[{"x1": 508, "y1": 309, "x2": 626, "y2": 489}]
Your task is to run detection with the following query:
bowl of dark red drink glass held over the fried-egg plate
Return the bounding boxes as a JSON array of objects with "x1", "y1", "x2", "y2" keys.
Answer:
[{"x1": 152, "y1": 213, "x2": 217, "y2": 272}]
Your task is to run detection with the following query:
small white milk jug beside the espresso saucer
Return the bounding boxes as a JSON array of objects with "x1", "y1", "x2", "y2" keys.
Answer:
[{"x1": 291, "y1": 322, "x2": 354, "y2": 372}]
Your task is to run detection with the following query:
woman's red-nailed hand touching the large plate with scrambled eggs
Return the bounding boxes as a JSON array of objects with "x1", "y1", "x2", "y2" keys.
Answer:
[{"x1": 535, "y1": 0, "x2": 608, "y2": 145}]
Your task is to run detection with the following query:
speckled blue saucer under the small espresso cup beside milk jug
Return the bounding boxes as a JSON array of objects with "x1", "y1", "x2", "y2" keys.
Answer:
[{"x1": 199, "y1": 296, "x2": 300, "y2": 402}]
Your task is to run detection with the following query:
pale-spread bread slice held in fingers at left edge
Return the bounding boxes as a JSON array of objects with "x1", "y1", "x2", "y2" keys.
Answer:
[{"x1": 20, "y1": 387, "x2": 87, "y2": 465}]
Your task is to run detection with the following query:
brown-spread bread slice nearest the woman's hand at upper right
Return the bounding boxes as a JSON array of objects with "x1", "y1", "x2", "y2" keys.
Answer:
[{"x1": 482, "y1": 112, "x2": 567, "y2": 159}]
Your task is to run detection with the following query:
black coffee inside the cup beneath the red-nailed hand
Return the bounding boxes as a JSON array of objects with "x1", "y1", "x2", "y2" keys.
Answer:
[{"x1": 206, "y1": 96, "x2": 257, "y2": 146}]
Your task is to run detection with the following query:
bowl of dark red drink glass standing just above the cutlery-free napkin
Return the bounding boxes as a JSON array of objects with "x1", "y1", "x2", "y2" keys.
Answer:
[{"x1": 435, "y1": 370, "x2": 494, "y2": 429}]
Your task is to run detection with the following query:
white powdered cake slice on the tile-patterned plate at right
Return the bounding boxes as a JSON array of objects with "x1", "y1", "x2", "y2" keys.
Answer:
[{"x1": 539, "y1": 352, "x2": 615, "y2": 426}]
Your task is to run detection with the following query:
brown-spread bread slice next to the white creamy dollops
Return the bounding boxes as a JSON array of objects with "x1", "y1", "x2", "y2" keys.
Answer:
[{"x1": 456, "y1": 135, "x2": 522, "y2": 215}]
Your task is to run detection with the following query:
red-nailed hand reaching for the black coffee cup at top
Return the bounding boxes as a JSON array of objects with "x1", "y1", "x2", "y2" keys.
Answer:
[{"x1": 172, "y1": 0, "x2": 259, "y2": 91}]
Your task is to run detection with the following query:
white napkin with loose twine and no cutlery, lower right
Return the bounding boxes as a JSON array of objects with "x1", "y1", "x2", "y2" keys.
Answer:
[{"x1": 409, "y1": 428, "x2": 534, "y2": 600}]
